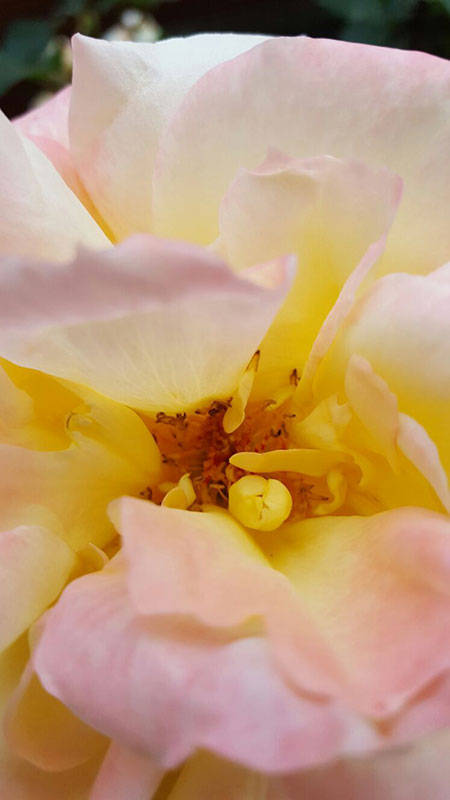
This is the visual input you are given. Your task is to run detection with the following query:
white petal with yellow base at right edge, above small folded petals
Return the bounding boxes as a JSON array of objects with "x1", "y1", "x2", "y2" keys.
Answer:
[{"x1": 314, "y1": 270, "x2": 450, "y2": 482}]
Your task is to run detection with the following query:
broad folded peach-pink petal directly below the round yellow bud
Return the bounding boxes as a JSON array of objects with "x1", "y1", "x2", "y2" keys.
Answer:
[{"x1": 117, "y1": 499, "x2": 450, "y2": 732}]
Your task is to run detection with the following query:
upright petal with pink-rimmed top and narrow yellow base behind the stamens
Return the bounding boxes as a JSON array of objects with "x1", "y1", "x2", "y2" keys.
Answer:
[{"x1": 215, "y1": 151, "x2": 401, "y2": 397}]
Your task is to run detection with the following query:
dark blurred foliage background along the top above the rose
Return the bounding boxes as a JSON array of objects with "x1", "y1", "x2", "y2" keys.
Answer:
[{"x1": 0, "y1": 0, "x2": 450, "y2": 113}]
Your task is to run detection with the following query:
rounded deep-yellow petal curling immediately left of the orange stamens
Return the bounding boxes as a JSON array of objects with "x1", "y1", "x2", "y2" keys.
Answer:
[{"x1": 0, "y1": 393, "x2": 160, "y2": 552}]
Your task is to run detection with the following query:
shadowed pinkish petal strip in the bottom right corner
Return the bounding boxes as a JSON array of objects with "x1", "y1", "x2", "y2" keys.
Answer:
[{"x1": 267, "y1": 731, "x2": 450, "y2": 800}]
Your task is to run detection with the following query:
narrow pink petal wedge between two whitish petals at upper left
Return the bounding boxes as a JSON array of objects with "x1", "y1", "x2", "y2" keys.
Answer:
[{"x1": 13, "y1": 86, "x2": 103, "y2": 223}]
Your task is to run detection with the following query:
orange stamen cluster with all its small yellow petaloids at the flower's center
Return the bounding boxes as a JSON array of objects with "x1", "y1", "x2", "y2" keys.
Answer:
[{"x1": 147, "y1": 374, "x2": 352, "y2": 530}]
